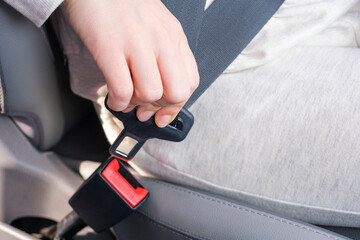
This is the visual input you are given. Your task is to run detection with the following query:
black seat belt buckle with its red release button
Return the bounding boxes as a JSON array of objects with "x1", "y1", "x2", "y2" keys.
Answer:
[{"x1": 69, "y1": 157, "x2": 149, "y2": 232}]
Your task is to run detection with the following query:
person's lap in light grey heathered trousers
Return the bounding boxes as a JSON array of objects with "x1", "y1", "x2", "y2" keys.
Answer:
[{"x1": 134, "y1": 47, "x2": 360, "y2": 227}]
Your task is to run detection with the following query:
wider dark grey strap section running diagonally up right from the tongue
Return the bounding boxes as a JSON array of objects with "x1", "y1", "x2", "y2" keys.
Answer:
[{"x1": 185, "y1": 0, "x2": 284, "y2": 108}]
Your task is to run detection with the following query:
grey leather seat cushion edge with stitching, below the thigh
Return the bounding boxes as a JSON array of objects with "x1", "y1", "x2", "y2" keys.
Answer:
[{"x1": 130, "y1": 178, "x2": 347, "y2": 239}]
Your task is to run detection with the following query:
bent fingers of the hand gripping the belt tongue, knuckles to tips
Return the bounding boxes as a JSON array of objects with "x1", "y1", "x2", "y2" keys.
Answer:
[{"x1": 102, "y1": 35, "x2": 199, "y2": 127}]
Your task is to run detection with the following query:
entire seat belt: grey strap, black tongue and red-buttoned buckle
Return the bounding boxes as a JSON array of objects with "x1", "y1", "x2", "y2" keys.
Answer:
[{"x1": 55, "y1": 0, "x2": 283, "y2": 239}]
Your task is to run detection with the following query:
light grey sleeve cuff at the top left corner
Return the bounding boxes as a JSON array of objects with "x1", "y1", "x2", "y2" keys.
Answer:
[{"x1": 4, "y1": 0, "x2": 63, "y2": 27}]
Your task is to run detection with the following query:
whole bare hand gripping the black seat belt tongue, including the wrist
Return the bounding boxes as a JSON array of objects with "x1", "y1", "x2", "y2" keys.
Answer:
[{"x1": 64, "y1": 0, "x2": 199, "y2": 127}]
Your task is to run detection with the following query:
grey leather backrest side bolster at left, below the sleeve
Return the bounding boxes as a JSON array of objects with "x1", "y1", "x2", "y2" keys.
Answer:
[{"x1": 0, "y1": 1, "x2": 65, "y2": 150}]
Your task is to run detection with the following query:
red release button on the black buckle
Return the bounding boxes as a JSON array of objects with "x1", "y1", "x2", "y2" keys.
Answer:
[{"x1": 101, "y1": 159, "x2": 149, "y2": 207}]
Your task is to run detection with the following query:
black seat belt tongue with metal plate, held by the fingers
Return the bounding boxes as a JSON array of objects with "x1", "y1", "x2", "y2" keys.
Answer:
[{"x1": 105, "y1": 96, "x2": 194, "y2": 161}]
